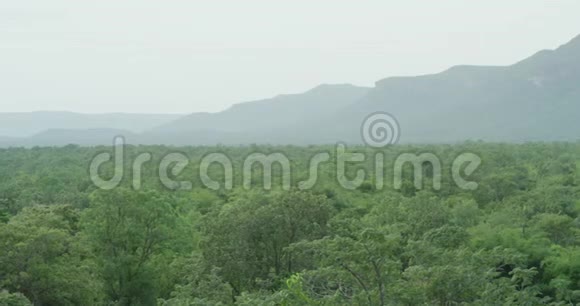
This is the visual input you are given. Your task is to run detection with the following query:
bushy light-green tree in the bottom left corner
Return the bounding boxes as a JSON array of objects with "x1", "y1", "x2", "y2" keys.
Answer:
[{"x1": 0, "y1": 205, "x2": 102, "y2": 305}]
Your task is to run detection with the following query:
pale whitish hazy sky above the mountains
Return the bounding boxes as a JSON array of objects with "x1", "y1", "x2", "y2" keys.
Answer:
[{"x1": 0, "y1": 0, "x2": 580, "y2": 113}]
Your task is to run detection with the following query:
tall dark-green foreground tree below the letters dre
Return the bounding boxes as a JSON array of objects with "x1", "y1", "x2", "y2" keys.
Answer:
[{"x1": 83, "y1": 189, "x2": 175, "y2": 305}]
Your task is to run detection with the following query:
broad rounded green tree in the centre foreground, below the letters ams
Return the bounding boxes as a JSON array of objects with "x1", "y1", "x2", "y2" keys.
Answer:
[{"x1": 203, "y1": 191, "x2": 331, "y2": 294}]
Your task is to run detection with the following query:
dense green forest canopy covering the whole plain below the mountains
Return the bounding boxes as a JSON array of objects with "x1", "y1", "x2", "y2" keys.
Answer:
[{"x1": 0, "y1": 142, "x2": 580, "y2": 306}]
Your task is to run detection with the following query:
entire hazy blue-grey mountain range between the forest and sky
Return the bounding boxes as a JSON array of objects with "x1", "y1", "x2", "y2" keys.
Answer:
[{"x1": 0, "y1": 36, "x2": 580, "y2": 146}]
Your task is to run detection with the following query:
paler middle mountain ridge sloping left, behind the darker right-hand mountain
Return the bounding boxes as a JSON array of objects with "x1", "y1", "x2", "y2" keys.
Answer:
[{"x1": 139, "y1": 84, "x2": 370, "y2": 144}]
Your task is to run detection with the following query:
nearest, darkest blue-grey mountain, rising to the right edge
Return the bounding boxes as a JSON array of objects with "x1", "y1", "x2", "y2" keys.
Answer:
[{"x1": 333, "y1": 32, "x2": 580, "y2": 142}]
